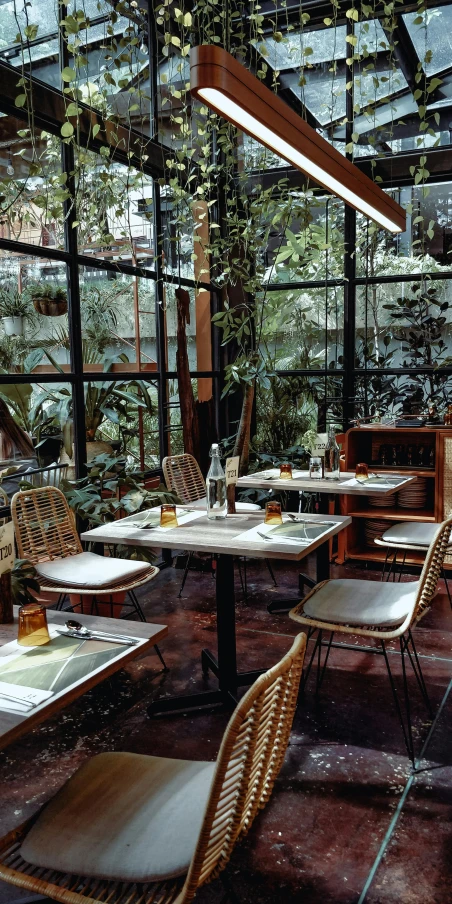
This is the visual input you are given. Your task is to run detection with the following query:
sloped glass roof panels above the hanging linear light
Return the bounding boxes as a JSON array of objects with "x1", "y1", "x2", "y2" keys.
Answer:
[{"x1": 256, "y1": 5, "x2": 452, "y2": 155}]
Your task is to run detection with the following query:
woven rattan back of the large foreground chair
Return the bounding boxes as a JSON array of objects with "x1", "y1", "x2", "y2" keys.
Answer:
[{"x1": 177, "y1": 634, "x2": 306, "y2": 904}]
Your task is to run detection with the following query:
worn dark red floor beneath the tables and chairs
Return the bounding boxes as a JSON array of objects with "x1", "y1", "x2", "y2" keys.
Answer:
[{"x1": 0, "y1": 562, "x2": 452, "y2": 904}]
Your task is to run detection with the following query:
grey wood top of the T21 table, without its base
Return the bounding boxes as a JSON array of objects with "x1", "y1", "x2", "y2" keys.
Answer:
[{"x1": 81, "y1": 507, "x2": 352, "y2": 561}]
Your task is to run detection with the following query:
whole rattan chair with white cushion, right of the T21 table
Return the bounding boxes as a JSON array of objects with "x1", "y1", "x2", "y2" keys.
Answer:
[{"x1": 289, "y1": 517, "x2": 452, "y2": 762}]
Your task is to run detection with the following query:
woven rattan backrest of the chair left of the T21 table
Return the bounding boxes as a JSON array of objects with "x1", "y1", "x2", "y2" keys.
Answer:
[{"x1": 11, "y1": 487, "x2": 83, "y2": 565}]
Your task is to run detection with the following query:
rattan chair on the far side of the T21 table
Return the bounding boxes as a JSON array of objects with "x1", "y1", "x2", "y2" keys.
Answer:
[{"x1": 162, "y1": 452, "x2": 276, "y2": 599}]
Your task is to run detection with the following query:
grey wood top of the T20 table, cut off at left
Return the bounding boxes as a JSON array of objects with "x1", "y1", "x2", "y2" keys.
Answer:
[{"x1": 0, "y1": 607, "x2": 168, "y2": 749}]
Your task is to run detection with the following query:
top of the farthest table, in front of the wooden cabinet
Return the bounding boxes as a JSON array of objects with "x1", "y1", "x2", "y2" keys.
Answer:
[{"x1": 237, "y1": 469, "x2": 416, "y2": 496}]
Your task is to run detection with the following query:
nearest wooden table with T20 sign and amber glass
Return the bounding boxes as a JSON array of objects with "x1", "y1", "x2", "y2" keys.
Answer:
[{"x1": 0, "y1": 607, "x2": 168, "y2": 749}]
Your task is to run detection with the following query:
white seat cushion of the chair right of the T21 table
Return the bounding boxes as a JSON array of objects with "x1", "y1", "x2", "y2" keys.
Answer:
[{"x1": 303, "y1": 579, "x2": 418, "y2": 628}]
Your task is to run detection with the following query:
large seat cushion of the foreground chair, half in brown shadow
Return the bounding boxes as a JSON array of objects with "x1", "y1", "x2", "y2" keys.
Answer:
[{"x1": 21, "y1": 753, "x2": 215, "y2": 882}]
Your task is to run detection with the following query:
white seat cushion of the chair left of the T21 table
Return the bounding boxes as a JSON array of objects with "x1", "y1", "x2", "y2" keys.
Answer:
[{"x1": 35, "y1": 552, "x2": 149, "y2": 588}]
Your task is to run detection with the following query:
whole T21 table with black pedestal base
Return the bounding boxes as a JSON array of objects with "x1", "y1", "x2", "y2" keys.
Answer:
[{"x1": 82, "y1": 507, "x2": 351, "y2": 715}]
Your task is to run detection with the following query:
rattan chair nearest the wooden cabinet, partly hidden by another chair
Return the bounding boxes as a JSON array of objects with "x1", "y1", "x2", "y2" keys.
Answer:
[{"x1": 374, "y1": 521, "x2": 452, "y2": 608}]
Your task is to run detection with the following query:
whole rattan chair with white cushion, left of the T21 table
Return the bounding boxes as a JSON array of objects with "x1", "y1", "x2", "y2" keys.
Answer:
[{"x1": 11, "y1": 486, "x2": 166, "y2": 668}]
